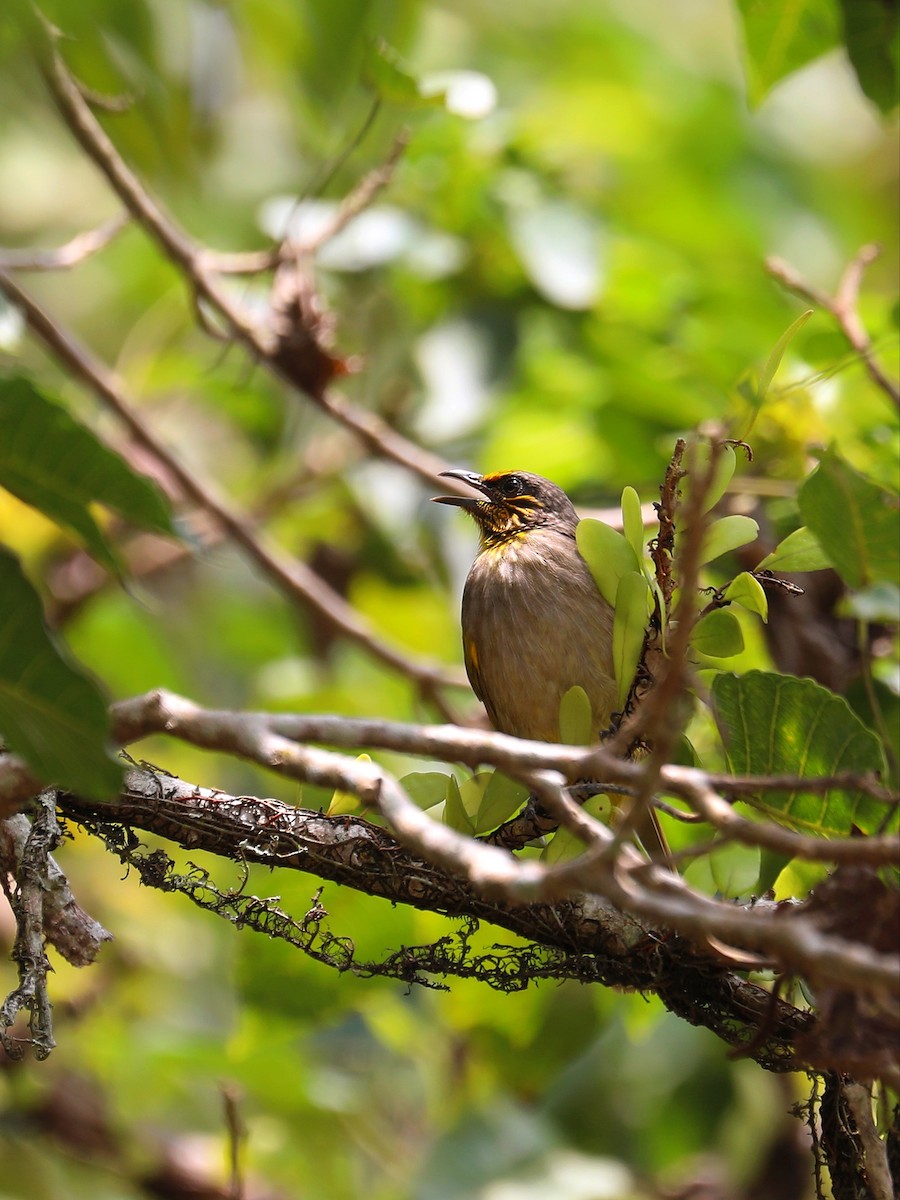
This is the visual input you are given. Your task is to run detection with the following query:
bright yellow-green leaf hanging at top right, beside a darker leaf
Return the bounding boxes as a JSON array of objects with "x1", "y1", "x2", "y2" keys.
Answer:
[{"x1": 738, "y1": 0, "x2": 854, "y2": 107}]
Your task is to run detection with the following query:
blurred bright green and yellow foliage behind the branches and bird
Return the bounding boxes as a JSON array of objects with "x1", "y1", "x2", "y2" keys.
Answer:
[{"x1": 0, "y1": 0, "x2": 898, "y2": 1200}]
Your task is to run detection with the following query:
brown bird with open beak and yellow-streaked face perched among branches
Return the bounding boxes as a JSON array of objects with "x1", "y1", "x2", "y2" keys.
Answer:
[{"x1": 432, "y1": 470, "x2": 670, "y2": 862}]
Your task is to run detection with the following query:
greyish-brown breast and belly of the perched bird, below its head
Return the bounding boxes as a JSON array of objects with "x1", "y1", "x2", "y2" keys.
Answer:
[{"x1": 463, "y1": 544, "x2": 616, "y2": 742}]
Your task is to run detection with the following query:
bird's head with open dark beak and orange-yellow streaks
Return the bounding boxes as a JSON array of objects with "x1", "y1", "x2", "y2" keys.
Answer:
[{"x1": 433, "y1": 470, "x2": 578, "y2": 547}]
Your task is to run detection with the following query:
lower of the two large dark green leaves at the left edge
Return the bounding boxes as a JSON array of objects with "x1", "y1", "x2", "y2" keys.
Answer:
[{"x1": 0, "y1": 546, "x2": 122, "y2": 800}]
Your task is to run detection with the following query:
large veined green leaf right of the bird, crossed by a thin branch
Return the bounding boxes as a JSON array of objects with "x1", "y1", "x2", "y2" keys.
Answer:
[{"x1": 712, "y1": 671, "x2": 886, "y2": 836}]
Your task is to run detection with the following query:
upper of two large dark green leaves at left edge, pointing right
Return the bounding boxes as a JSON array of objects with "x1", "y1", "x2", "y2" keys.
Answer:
[{"x1": 0, "y1": 376, "x2": 175, "y2": 570}]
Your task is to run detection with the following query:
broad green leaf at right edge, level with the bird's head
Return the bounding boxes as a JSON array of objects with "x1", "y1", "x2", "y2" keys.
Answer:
[{"x1": 798, "y1": 450, "x2": 900, "y2": 588}]
